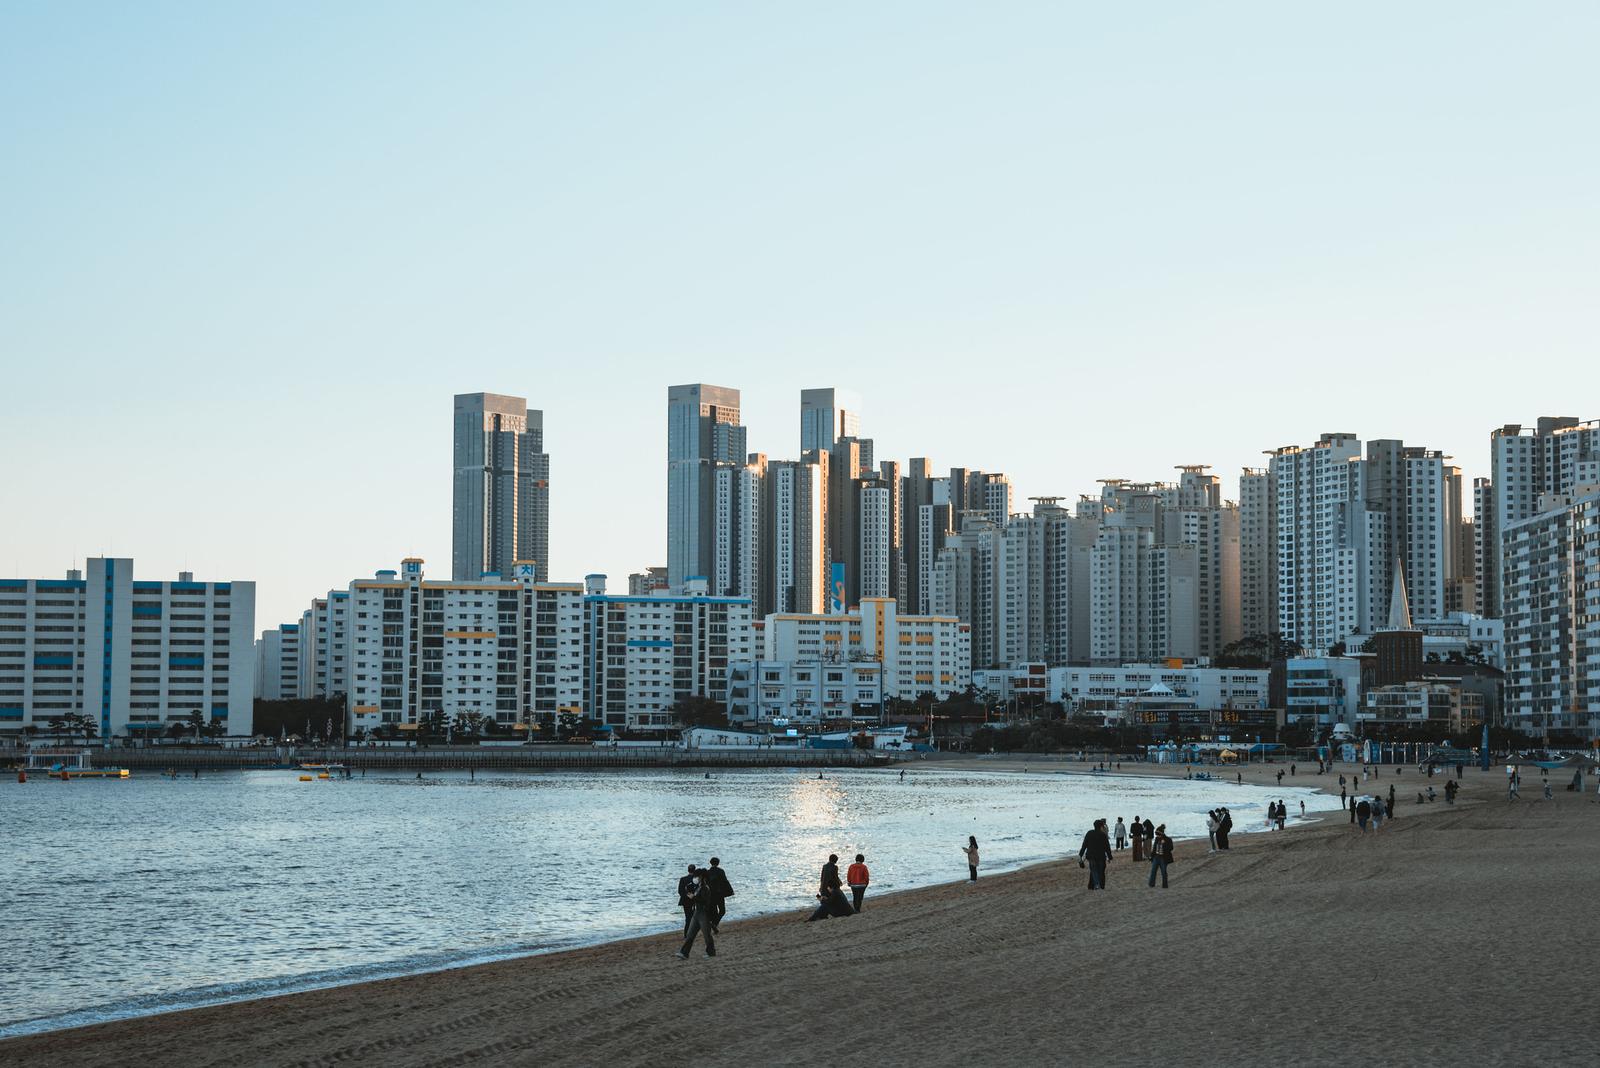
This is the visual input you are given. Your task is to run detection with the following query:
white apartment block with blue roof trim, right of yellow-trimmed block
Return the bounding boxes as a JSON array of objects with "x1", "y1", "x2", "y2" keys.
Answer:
[{"x1": 582, "y1": 574, "x2": 755, "y2": 734}]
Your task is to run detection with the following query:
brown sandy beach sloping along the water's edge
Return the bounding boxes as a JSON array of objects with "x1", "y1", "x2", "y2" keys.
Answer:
[{"x1": 9, "y1": 759, "x2": 1600, "y2": 1068}]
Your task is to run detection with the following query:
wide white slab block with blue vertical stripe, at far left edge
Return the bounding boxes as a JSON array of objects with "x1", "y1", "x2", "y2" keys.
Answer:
[{"x1": 0, "y1": 556, "x2": 256, "y2": 740}]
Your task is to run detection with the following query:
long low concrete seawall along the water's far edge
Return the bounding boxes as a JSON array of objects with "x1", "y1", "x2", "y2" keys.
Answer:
[{"x1": 0, "y1": 745, "x2": 882, "y2": 771}]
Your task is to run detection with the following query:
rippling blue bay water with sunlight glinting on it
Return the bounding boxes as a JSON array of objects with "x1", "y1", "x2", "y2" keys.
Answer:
[{"x1": 0, "y1": 767, "x2": 1339, "y2": 1036}]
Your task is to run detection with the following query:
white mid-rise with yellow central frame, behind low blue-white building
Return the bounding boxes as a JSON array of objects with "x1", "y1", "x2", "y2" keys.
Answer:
[{"x1": 762, "y1": 598, "x2": 973, "y2": 700}]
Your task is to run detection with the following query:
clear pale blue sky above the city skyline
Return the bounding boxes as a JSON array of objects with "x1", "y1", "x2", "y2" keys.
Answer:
[{"x1": 0, "y1": 0, "x2": 1600, "y2": 627}]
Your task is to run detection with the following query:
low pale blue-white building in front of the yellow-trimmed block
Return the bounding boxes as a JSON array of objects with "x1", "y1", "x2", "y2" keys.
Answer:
[{"x1": 728, "y1": 659, "x2": 883, "y2": 727}]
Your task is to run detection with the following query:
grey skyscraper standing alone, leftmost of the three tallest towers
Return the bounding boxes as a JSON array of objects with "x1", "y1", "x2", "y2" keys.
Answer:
[{"x1": 450, "y1": 393, "x2": 550, "y2": 582}]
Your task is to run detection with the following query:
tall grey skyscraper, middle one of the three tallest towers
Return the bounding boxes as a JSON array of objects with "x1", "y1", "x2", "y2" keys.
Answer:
[{"x1": 667, "y1": 382, "x2": 746, "y2": 587}]
